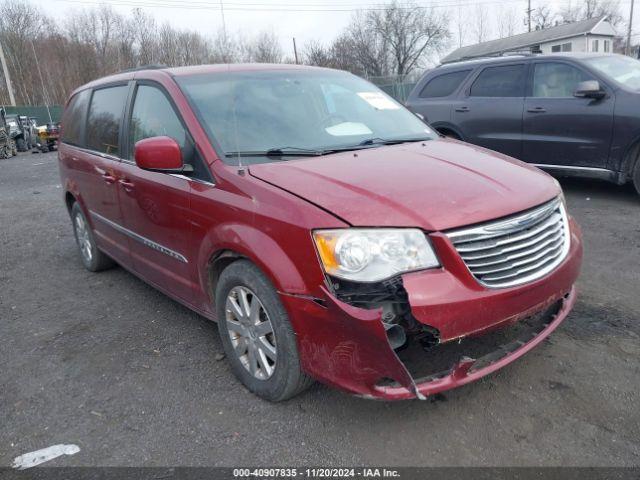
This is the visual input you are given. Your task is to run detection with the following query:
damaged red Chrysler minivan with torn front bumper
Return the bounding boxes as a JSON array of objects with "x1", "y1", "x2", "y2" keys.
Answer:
[{"x1": 59, "y1": 65, "x2": 582, "y2": 401}]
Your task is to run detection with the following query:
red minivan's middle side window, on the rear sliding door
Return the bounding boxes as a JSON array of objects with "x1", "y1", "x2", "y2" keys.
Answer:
[{"x1": 87, "y1": 85, "x2": 129, "y2": 156}]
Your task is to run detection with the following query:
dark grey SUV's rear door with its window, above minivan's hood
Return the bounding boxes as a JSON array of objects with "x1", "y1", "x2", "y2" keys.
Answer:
[{"x1": 452, "y1": 63, "x2": 527, "y2": 158}]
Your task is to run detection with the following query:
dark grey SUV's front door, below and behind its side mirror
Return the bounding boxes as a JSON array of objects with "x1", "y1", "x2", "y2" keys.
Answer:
[{"x1": 523, "y1": 61, "x2": 614, "y2": 168}]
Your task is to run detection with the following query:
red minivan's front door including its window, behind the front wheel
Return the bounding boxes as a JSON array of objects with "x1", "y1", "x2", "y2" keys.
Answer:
[{"x1": 118, "y1": 84, "x2": 197, "y2": 302}]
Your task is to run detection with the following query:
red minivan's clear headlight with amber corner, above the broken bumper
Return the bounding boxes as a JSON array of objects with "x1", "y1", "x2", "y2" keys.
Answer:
[{"x1": 313, "y1": 228, "x2": 440, "y2": 282}]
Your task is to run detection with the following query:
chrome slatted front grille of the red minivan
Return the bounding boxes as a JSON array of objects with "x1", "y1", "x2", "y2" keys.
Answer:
[{"x1": 447, "y1": 199, "x2": 569, "y2": 288}]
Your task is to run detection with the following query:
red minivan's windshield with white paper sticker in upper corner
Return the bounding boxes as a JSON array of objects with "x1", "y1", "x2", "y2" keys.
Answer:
[{"x1": 177, "y1": 70, "x2": 436, "y2": 163}]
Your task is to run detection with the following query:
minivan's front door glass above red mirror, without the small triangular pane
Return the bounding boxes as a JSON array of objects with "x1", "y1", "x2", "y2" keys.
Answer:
[{"x1": 129, "y1": 85, "x2": 186, "y2": 152}]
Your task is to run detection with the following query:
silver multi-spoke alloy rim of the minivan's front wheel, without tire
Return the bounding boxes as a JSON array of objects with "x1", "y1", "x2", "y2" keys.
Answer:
[{"x1": 225, "y1": 286, "x2": 277, "y2": 380}]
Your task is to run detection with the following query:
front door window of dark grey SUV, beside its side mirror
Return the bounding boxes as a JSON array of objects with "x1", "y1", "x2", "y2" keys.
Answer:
[{"x1": 533, "y1": 63, "x2": 592, "y2": 98}]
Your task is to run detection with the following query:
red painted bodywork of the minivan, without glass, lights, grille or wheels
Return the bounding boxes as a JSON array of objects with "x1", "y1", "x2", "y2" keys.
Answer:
[{"x1": 59, "y1": 65, "x2": 582, "y2": 399}]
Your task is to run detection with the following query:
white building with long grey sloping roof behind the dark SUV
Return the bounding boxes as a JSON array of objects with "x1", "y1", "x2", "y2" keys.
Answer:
[{"x1": 441, "y1": 16, "x2": 616, "y2": 63}]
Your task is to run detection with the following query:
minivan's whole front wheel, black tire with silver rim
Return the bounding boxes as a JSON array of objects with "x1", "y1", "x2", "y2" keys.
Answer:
[{"x1": 215, "y1": 260, "x2": 314, "y2": 402}]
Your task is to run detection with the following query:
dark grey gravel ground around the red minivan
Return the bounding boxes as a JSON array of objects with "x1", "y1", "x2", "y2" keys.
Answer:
[{"x1": 0, "y1": 153, "x2": 640, "y2": 466}]
